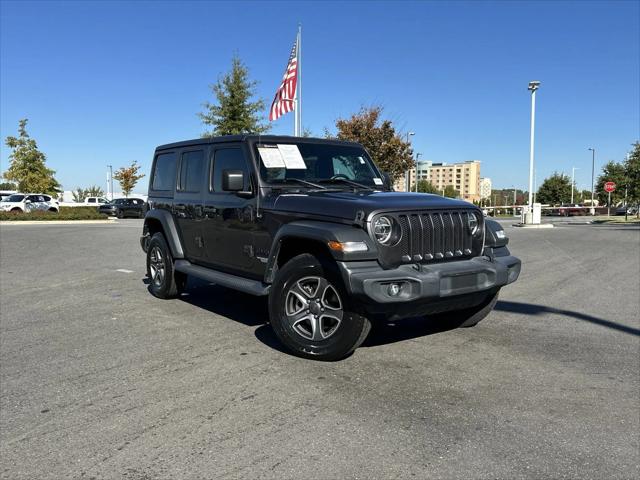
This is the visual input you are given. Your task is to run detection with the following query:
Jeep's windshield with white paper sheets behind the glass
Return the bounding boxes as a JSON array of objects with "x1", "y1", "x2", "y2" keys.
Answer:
[{"x1": 256, "y1": 143, "x2": 383, "y2": 189}]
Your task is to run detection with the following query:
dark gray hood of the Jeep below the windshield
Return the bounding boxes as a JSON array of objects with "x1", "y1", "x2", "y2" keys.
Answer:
[{"x1": 264, "y1": 191, "x2": 475, "y2": 220}]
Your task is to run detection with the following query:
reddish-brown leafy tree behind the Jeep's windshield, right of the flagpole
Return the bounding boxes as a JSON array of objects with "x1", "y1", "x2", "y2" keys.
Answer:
[{"x1": 325, "y1": 106, "x2": 414, "y2": 180}]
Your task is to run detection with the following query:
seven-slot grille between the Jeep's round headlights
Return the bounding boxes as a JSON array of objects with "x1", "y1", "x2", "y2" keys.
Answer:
[{"x1": 394, "y1": 210, "x2": 473, "y2": 263}]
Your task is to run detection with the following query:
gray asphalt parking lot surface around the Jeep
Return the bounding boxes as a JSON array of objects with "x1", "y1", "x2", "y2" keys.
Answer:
[{"x1": 0, "y1": 220, "x2": 640, "y2": 479}]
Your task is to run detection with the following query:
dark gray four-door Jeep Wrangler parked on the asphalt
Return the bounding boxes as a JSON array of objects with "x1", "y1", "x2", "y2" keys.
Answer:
[{"x1": 141, "y1": 136, "x2": 520, "y2": 360}]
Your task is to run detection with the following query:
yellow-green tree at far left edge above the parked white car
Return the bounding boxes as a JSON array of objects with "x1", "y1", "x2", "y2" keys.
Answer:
[{"x1": 2, "y1": 118, "x2": 60, "y2": 195}]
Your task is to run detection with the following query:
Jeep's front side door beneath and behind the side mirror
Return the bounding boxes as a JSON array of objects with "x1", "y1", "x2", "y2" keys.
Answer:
[{"x1": 202, "y1": 144, "x2": 259, "y2": 276}]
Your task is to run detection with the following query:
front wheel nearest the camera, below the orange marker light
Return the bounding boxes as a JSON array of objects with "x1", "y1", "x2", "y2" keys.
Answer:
[{"x1": 269, "y1": 253, "x2": 371, "y2": 361}]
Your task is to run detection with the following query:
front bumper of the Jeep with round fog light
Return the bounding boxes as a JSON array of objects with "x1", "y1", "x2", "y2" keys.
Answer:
[{"x1": 338, "y1": 255, "x2": 520, "y2": 304}]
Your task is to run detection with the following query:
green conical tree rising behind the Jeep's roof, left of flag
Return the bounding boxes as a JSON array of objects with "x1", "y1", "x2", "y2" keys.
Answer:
[{"x1": 198, "y1": 56, "x2": 269, "y2": 137}]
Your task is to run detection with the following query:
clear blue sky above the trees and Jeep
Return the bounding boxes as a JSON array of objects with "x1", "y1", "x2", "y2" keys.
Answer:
[{"x1": 0, "y1": 0, "x2": 640, "y2": 191}]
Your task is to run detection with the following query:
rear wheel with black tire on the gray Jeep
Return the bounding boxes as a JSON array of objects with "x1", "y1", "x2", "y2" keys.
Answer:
[{"x1": 147, "y1": 232, "x2": 181, "y2": 299}]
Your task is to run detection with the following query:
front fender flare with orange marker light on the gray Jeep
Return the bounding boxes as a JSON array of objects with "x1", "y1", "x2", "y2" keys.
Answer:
[{"x1": 264, "y1": 220, "x2": 378, "y2": 283}]
